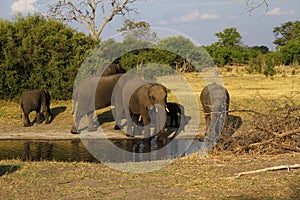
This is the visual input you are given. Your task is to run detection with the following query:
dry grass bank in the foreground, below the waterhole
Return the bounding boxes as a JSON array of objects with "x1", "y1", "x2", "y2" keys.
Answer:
[{"x1": 0, "y1": 154, "x2": 300, "y2": 199}]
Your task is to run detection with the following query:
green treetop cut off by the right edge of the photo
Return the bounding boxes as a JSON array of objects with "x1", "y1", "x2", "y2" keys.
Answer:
[{"x1": 273, "y1": 21, "x2": 300, "y2": 46}]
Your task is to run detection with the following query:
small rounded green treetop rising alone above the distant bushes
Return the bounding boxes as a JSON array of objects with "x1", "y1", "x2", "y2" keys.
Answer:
[{"x1": 215, "y1": 27, "x2": 242, "y2": 48}]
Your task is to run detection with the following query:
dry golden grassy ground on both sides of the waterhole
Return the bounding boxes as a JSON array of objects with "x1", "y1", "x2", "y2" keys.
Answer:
[{"x1": 0, "y1": 67, "x2": 300, "y2": 199}]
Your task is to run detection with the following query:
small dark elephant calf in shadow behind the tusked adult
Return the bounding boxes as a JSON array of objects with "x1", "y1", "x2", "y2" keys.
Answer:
[{"x1": 167, "y1": 102, "x2": 186, "y2": 128}]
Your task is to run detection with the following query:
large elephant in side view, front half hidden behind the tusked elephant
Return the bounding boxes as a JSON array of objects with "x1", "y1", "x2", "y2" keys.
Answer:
[{"x1": 71, "y1": 74, "x2": 124, "y2": 134}]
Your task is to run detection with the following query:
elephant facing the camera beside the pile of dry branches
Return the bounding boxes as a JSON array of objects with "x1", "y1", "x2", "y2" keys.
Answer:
[{"x1": 200, "y1": 83, "x2": 230, "y2": 140}]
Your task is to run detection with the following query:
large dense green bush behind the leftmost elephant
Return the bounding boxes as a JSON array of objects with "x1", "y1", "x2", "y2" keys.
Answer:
[{"x1": 0, "y1": 15, "x2": 94, "y2": 99}]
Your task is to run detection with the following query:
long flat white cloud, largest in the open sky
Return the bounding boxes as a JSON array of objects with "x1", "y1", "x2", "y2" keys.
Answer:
[{"x1": 159, "y1": 9, "x2": 219, "y2": 25}]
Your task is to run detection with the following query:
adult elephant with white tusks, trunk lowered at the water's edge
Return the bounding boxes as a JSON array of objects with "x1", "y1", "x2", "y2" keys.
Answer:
[{"x1": 114, "y1": 74, "x2": 167, "y2": 141}]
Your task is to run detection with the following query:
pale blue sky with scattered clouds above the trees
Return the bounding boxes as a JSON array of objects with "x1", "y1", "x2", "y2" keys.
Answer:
[{"x1": 0, "y1": 0, "x2": 300, "y2": 50}]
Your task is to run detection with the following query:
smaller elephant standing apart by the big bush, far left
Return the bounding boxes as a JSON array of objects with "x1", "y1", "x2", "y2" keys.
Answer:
[{"x1": 20, "y1": 89, "x2": 53, "y2": 127}]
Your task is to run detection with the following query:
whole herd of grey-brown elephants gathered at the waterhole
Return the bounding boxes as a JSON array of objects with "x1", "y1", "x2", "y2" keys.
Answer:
[{"x1": 20, "y1": 64, "x2": 239, "y2": 142}]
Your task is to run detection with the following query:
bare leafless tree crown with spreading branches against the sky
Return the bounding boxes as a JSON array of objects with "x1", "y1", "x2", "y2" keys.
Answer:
[{"x1": 50, "y1": 0, "x2": 143, "y2": 42}]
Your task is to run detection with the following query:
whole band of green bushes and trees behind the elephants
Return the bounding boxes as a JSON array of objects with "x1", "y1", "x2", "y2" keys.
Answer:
[{"x1": 0, "y1": 14, "x2": 300, "y2": 100}]
